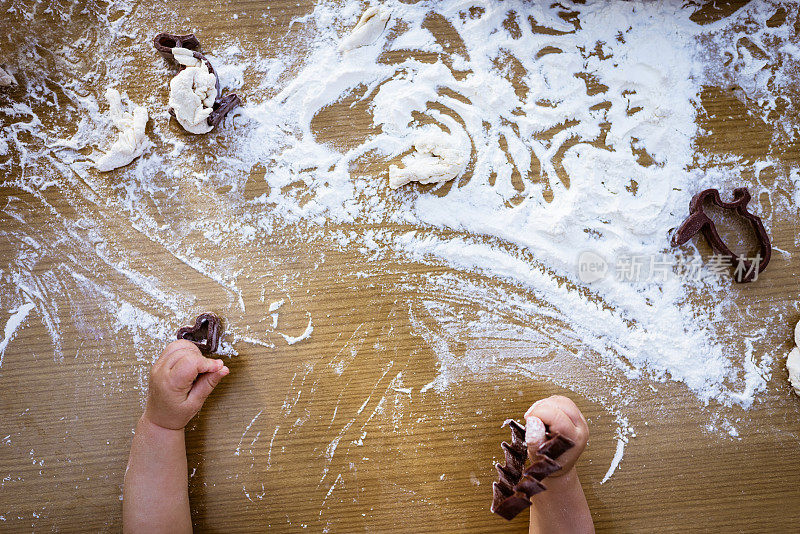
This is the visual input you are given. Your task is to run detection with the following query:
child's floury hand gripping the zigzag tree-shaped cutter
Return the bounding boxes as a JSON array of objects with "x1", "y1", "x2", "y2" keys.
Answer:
[{"x1": 525, "y1": 395, "x2": 589, "y2": 477}]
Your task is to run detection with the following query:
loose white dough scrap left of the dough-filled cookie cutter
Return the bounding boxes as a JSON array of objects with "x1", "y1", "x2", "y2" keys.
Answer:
[{"x1": 95, "y1": 88, "x2": 150, "y2": 172}]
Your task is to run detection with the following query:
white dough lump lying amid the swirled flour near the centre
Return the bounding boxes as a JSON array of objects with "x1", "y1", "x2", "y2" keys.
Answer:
[{"x1": 389, "y1": 130, "x2": 469, "y2": 189}]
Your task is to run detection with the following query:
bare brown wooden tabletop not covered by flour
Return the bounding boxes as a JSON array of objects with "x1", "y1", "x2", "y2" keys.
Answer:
[{"x1": 0, "y1": 0, "x2": 800, "y2": 532}]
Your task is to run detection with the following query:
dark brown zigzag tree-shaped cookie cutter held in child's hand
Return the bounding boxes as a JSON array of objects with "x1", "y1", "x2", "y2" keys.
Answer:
[{"x1": 491, "y1": 419, "x2": 575, "y2": 521}]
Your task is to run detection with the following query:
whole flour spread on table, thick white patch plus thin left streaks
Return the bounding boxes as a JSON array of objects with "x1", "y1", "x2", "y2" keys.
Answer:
[{"x1": 0, "y1": 1, "x2": 800, "y2": 448}]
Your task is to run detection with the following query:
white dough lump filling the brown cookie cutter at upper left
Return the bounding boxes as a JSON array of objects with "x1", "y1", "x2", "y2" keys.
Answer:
[{"x1": 169, "y1": 47, "x2": 217, "y2": 134}]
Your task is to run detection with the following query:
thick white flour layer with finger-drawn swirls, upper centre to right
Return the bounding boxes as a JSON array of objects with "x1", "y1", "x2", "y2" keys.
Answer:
[{"x1": 234, "y1": 1, "x2": 794, "y2": 408}]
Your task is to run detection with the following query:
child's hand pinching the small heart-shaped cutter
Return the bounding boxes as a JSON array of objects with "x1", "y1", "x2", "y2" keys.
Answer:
[{"x1": 144, "y1": 340, "x2": 230, "y2": 430}]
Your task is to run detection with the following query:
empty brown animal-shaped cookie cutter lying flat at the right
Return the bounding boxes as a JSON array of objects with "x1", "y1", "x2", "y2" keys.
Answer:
[{"x1": 672, "y1": 187, "x2": 772, "y2": 282}]
